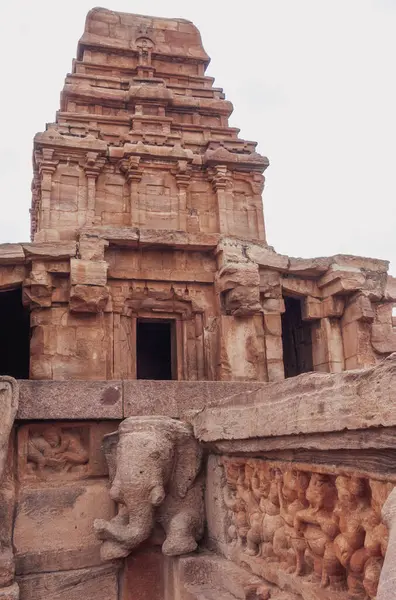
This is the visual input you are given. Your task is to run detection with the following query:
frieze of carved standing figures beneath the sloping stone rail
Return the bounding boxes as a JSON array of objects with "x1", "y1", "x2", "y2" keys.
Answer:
[{"x1": 222, "y1": 458, "x2": 394, "y2": 599}]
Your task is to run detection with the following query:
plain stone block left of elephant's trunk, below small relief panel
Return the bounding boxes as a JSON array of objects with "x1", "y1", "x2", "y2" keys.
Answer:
[{"x1": 14, "y1": 477, "x2": 114, "y2": 575}]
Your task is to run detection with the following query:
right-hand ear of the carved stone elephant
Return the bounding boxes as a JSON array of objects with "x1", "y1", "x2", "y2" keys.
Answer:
[{"x1": 170, "y1": 424, "x2": 202, "y2": 498}]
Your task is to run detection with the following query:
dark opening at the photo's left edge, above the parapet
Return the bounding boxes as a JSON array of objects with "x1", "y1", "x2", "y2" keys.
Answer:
[{"x1": 0, "y1": 289, "x2": 30, "y2": 379}]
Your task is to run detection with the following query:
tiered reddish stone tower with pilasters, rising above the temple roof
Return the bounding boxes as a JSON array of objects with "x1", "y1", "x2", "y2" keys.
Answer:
[{"x1": 32, "y1": 9, "x2": 268, "y2": 241}]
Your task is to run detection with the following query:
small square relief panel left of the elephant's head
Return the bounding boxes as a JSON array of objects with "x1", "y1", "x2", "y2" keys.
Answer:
[{"x1": 20, "y1": 424, "x2": 89, "y2": 480}]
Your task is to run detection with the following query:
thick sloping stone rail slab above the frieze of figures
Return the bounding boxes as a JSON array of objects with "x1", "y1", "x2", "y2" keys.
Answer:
[{"x1": 191, "y1": 354, "x2": 396, "y2": 441}]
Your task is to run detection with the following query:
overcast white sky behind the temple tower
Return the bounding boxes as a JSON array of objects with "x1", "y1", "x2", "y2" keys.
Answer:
[{"x1": 0, "y1": 0, "x2": 396, "y2": 275}]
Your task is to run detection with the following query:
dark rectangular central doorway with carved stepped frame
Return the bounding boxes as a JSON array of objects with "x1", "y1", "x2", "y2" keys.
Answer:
[{"x1": 136, "y1": 319, "x2": 176, "y2": 379}]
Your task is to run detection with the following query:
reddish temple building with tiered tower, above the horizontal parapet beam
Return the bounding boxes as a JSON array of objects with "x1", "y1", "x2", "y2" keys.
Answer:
[{"x1": 0, "y1": 9, "x2": 396, "y2": 381}]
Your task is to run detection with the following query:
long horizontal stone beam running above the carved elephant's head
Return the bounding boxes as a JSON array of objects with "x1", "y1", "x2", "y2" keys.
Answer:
[{"x1": 17, "y1": 380, "x2": 264, "y2": 420}]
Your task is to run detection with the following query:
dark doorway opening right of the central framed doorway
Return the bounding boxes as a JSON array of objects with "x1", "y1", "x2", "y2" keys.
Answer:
[{"x1": 282, "y1": 296, "x2": 313, "y2": 377}]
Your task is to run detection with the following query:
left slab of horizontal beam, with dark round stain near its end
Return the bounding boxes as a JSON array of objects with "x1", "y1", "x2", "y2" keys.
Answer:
[{"x1": 18, "y1": 381, "x2": 123, "y2": 420}]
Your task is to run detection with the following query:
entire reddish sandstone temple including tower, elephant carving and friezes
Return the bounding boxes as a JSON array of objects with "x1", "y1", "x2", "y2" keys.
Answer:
[{"x1": 0, "y1": 8, "x2": 396, "y2": 600}]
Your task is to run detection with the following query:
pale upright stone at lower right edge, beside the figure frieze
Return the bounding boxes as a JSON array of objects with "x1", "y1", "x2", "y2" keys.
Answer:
[{"x1": 377, "y1": 488, "x2": 396, "y2": 600}]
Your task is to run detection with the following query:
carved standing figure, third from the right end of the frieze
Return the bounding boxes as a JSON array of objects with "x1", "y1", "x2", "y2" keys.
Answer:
[{"x1": 294, "y1": 473, "x2": 345, "y2": 589}]
